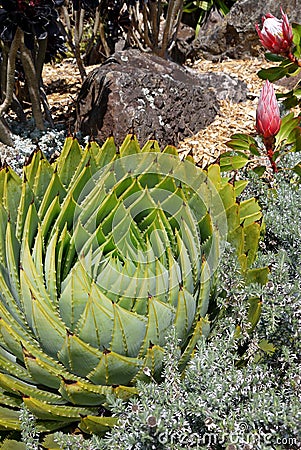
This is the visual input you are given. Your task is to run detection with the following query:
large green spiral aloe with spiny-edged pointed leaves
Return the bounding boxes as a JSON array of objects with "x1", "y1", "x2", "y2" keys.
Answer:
[{"x1": 0, "y1": 135, "x2": 262, "y2": 433}]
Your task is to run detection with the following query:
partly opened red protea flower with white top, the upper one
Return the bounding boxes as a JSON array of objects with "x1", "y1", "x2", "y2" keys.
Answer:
[{"x1": 255, "y1": 8, "x2": 293, "y2": 55}]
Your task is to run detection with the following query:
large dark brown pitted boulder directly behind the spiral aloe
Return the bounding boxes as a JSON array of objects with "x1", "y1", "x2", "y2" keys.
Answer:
[{"x1": 76, "y1": 49, "x2": 246, "y2": 146}]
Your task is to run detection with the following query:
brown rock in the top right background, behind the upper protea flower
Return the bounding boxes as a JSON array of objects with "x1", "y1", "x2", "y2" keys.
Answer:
[{"x1": 189, "y1": 0, "x2": 301, "y2": 60}]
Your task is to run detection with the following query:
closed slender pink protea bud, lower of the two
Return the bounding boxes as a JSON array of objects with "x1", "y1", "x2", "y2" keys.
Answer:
[{"x1": 256, "y1": 80, "x2": 281, "y2": 139}]
